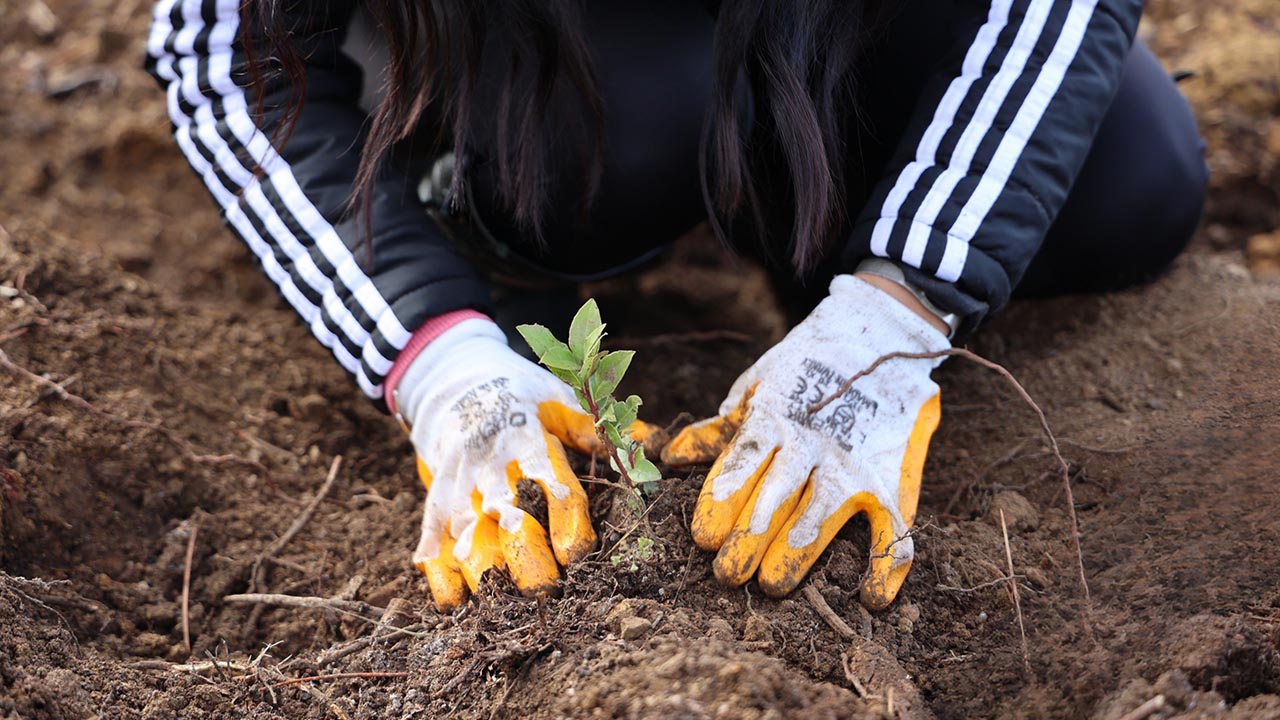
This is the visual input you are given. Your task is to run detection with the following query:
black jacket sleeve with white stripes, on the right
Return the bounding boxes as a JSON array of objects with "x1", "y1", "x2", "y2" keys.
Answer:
[{"x1": 845, "y1": 0, "x2": 1142, "y2": 333}]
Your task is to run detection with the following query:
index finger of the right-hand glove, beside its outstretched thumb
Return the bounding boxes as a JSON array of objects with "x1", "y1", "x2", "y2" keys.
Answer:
[{"x1": 690, "y1": 417, "x2": 778, "y2": 550}]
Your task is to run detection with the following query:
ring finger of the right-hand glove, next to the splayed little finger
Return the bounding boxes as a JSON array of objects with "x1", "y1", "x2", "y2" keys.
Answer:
[{"x1": 759, "y1": 479, "x2": 874, "y2": 597}]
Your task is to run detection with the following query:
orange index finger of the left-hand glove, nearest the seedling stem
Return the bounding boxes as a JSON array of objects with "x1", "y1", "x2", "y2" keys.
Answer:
[{"x1": 507, "y1": 430, "x2": 595, "y2": 565}]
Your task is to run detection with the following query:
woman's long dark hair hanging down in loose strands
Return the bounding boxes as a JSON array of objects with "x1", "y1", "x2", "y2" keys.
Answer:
[{"x1": 252, "y1": 0, "x2": 878, "y2": 274}]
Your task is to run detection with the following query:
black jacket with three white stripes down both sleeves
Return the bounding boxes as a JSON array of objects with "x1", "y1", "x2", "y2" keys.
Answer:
[{"x1": 147, "y1": 0, "x2": 1142, "y2": 400}]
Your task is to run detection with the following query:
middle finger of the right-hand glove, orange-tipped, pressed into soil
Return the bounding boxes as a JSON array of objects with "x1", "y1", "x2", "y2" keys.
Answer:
[{"x1": 712, "y1": 447, "x2": 813, "y2": 587}]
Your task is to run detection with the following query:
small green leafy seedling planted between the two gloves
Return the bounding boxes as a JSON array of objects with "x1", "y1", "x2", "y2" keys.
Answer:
[{"x1": 516, "y1": 300, "x2": 662, "y2": 496}]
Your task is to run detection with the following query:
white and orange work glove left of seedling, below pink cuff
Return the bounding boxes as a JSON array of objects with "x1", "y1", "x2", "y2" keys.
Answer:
[{"x1": 394, "y1": 319, "x2": 599, "y2": 610}]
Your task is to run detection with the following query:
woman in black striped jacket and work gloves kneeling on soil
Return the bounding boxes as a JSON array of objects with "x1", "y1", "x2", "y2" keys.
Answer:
[{"x1": 148, "y1": 0, "x2": 1206, "y2": 609}]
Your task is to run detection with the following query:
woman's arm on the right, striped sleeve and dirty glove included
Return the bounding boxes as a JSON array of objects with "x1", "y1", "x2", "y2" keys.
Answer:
[{"x1": 662, "y1": 0, "x2": 1142, "y2": 609}]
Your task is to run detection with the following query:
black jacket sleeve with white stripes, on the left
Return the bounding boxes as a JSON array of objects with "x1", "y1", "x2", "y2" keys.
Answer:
[{"x1": 147, "y1": 0, "x2": 489, "y2": 401}]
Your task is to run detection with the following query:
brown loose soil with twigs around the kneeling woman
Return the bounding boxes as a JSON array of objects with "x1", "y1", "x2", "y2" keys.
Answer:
[{"x1": 0, "y1": 0, "x2": 1280, "y2": 720}]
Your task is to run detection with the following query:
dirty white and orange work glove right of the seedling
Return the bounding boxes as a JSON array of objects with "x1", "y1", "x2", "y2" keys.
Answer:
[{"x1": 662, "y1": 275, "x2": 950, "y2": 610}]
